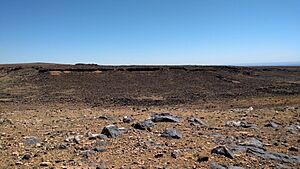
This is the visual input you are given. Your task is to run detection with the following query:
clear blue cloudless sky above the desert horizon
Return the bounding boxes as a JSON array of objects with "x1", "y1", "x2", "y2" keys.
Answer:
[{"x1": 0, "y1": 0, "x2": 300, "y2": 64}]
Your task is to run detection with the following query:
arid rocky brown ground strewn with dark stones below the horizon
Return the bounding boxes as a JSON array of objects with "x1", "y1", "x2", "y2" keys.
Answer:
[{"x1": 0, "y1": 64, "x2": 300, "y2": 169}]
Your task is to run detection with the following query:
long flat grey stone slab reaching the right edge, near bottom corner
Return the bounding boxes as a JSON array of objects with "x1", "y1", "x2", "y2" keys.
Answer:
[{"x1": 247, "y1": 147, "x2": 300, "y2": 163}]
